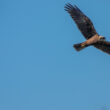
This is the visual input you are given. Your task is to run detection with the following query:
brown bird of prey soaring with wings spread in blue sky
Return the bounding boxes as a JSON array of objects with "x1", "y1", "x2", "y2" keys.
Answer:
[{"x1": 65, "y1": 3, "x2": 110, "y2": 54}]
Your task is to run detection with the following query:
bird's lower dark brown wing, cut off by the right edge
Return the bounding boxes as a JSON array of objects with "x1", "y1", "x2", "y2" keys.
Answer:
[{"x1": 94, "y1": 41, "x2": 110, "y2": 54}]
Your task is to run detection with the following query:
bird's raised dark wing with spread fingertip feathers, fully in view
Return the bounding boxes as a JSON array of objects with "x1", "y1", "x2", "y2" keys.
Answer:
[{"x1": 65, "y1": 4, "x2": 97, "y2": 39}]
